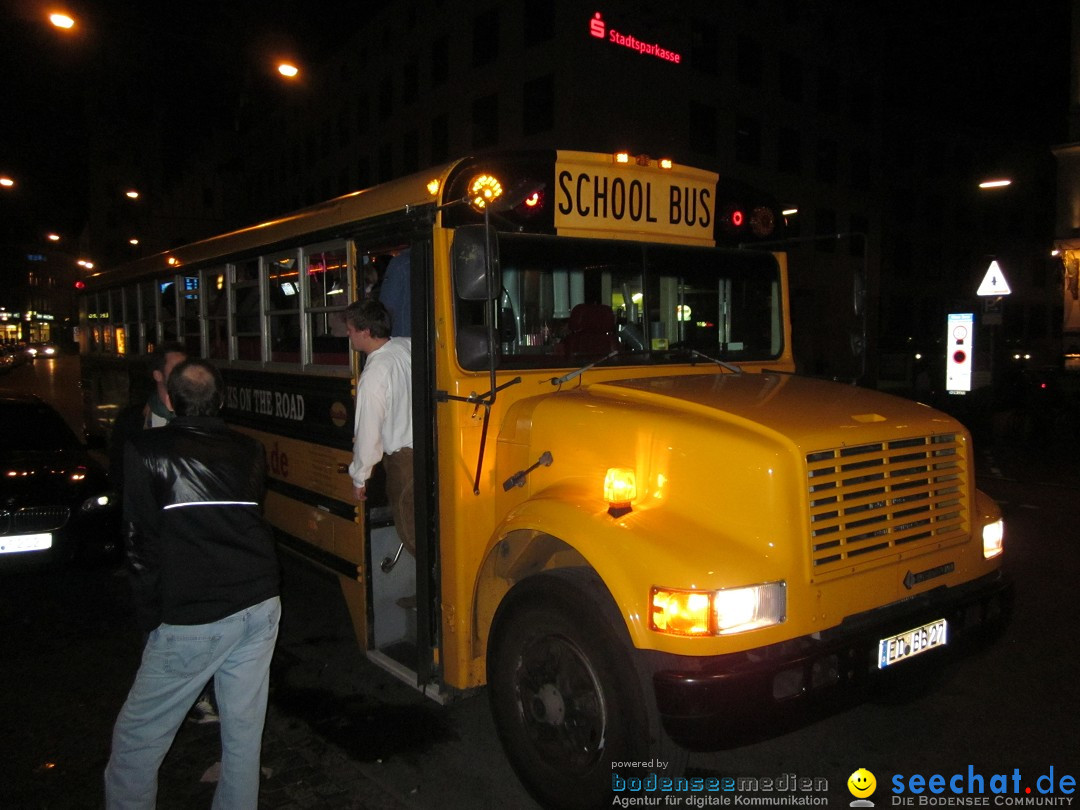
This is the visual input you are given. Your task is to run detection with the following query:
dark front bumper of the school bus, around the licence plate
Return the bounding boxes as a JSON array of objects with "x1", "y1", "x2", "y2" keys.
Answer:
[{"x1": 647, "y1": 571, "x2": 1012, "y2": 748}]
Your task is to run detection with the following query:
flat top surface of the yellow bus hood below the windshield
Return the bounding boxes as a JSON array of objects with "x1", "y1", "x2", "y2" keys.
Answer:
[{"x1": 588, "y1": 372, "x2": 960, "y2": 450}]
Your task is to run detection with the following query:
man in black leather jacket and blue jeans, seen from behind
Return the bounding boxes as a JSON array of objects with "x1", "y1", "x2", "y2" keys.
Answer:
[{"x1": 105, "y1": 360, "x2": 281, "y2": 809}]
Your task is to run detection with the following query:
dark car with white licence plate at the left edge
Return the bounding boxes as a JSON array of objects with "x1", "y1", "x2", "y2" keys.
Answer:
[{"x1": 0, "y1": 391, "x2": 120, "y2": 569}]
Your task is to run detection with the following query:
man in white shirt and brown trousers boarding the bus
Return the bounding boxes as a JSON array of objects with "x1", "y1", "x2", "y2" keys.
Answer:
[{"x1": 345, "y1": 299, "x2": 416, "y2": 556}]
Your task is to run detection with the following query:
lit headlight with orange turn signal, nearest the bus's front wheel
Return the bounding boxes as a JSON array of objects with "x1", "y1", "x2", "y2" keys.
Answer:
[{"x1": 649, "y1": 582, "x2": 787, "y2": 636}]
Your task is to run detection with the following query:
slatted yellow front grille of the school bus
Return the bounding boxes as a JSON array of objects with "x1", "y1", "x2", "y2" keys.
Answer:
[{"x1": 807, "y1": 434, "x2": 969, "y2": 573}]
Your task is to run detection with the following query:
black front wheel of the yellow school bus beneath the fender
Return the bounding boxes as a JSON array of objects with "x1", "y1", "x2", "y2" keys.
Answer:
[{"x1": 487, "y1": 573, "x2": 685, "y2": 808}]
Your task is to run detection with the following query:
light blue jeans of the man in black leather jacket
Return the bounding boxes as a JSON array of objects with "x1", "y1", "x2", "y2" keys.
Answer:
[{"x1": 105, "y1": 596, "x2": 281, "y2": 810}]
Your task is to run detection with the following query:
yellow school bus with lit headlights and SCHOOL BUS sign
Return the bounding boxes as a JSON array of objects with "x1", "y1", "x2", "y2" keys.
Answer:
[{"x1": 80, "y1": 151, "x2": 1008, "y2": 806}]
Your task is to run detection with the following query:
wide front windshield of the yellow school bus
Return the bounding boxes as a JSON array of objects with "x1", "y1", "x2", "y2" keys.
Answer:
[{"x1": 473, "y1": 234, "x2": 783, "y2": 368}]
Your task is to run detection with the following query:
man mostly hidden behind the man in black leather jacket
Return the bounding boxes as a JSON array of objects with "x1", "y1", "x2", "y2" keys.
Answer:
[{"x1": 109, "y1": 341, "x2": 219, "y2": 724}]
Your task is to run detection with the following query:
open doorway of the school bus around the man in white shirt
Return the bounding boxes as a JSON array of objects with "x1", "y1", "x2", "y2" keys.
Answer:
[{"x1": 347, "y1": 231, "x2": 438, "y2": 698}]
